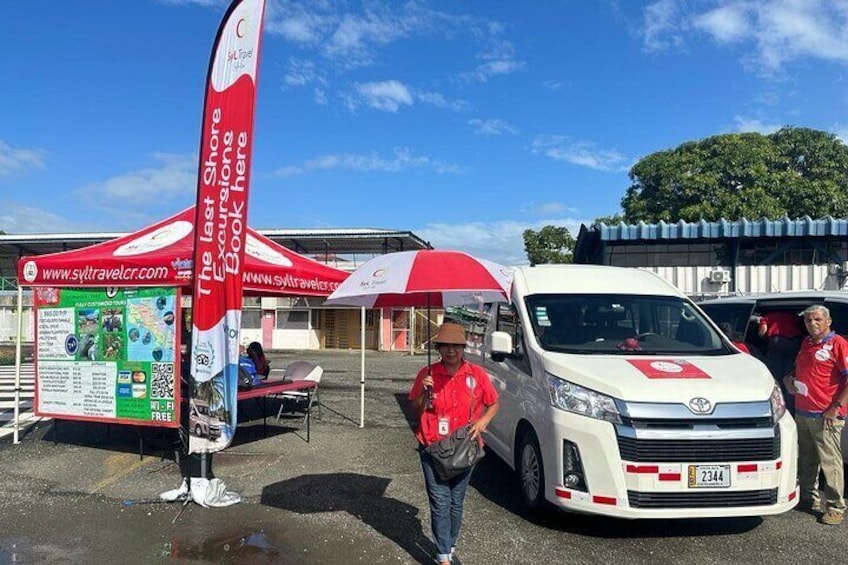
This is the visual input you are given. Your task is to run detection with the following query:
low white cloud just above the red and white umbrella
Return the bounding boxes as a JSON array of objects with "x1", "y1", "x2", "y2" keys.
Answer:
[{"x1": 413, "y1": 218, "x2": 590, "y2": 265}]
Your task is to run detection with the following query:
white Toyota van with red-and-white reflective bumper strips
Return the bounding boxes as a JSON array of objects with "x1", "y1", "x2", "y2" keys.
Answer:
[{"x1": 467, "y1": 265, "x2": 798, "y2": 518}]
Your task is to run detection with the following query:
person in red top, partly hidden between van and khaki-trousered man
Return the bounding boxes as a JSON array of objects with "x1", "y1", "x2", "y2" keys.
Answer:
[{"x1": 757, "y1": 310, "x2": 804, "y2": 414}]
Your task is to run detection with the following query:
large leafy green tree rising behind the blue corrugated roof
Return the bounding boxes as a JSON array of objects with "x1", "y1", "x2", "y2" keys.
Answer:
[{"x1": 621, "y1": 127, "x2": 848, "y2": 223}]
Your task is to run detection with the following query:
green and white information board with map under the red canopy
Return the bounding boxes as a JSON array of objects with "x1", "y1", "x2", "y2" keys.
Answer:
[{"x1": 34, "y1": 287, "x2": 182, "y2": 428}]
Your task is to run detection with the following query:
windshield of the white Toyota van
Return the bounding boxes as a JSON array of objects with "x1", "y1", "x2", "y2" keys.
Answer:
[{"x1": 526, "y1": 294, "x2": 732, "y2": 355}]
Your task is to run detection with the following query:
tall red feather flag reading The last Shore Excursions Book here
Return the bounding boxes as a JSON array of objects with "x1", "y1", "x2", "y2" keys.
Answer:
[{"x1": 188, "y1": 0, "x2": 265, "y2": 453}]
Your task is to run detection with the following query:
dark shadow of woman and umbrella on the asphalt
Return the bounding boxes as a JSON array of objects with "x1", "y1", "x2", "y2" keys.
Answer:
[{"x1": 260, "y1": 473, "x2": 435, "y2": 563}]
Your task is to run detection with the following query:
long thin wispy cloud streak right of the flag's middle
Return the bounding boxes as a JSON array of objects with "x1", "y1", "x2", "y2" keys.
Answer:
[{"x1": 276, "y1": 147, "x2": 464, "y2": 176}]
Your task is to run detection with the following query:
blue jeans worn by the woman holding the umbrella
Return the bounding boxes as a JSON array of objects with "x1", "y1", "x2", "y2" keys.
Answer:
[{"x1": 418, "y1": 445, "x2": 474, "y2": 561}]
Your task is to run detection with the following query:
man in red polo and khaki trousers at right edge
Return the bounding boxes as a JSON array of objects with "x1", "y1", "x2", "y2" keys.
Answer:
[{"x1": 783, "y1": 305, "x2": 848, "y2": 526}]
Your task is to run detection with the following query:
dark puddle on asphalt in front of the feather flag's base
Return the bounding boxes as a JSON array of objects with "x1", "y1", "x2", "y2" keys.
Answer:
[{"x1": 162, "y1": 531, "x2": 281, "y2": 564}]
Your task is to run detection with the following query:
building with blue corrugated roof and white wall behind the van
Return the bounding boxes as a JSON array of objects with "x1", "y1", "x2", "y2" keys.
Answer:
[{"x1": 574, "y1": 217, "x2": 848, "y2": 296}]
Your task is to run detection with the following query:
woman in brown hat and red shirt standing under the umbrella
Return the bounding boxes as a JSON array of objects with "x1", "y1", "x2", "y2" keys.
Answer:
[{"x1": 409, "y1": 323, "x2": 498, "y2": 565}]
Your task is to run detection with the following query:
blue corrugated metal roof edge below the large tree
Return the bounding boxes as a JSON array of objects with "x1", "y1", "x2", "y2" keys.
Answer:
[{"x1": 590, "y1": 216, "x2": 848, "y2": 241}]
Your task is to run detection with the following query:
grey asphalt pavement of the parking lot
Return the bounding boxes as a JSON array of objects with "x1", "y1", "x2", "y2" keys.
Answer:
[{"x1": 0, "y1": 351, "x2": 848, "y2": 565}]
